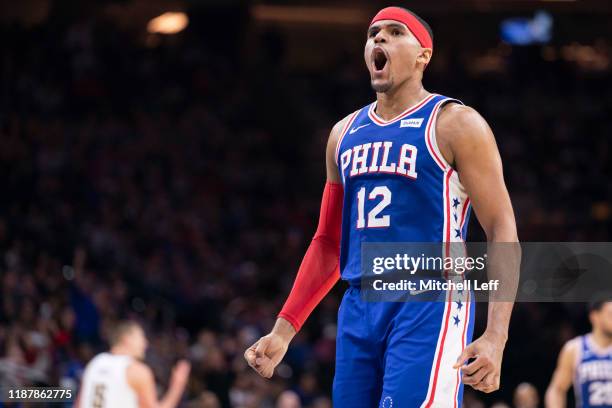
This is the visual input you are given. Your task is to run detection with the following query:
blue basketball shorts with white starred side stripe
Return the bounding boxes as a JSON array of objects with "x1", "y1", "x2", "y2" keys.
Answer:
[{"x1": 333, "y1": 286, "x2": 475, "y2": 408}]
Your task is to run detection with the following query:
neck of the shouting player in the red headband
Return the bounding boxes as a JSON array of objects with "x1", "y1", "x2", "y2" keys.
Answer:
[{"x1": 376, "y1": 80, "x2": 429, "y2": 120}]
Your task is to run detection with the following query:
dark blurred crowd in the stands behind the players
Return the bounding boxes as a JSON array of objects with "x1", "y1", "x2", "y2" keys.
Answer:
[{"x1": 0, "y1": 3, "x2": 612, "y2": 408}]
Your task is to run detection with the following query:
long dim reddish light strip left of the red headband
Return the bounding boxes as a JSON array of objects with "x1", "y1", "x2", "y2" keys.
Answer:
[{"x1": 251, "y1": 4, "x2": 371, "y2": 25}]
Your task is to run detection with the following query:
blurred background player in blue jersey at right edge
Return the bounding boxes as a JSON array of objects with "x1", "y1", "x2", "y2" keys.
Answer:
[{"x1": 546, "y1": 301, "x2": 612, "y2": 408}]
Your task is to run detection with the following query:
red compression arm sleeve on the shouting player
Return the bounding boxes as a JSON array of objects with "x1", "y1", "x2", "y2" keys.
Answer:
[{"x1": 278, "y1": 181, "x2": 344, "y2": 331}]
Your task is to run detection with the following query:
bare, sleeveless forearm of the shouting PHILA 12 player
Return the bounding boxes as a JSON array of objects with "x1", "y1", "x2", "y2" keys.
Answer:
[{"x1": 486, "y1": 221, "x2": 521, "y2": 341}]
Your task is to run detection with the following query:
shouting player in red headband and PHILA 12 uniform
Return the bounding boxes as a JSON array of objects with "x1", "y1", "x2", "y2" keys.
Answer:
[{"x1": 245, "y1": 7, "x2": 518, "y2": 408}]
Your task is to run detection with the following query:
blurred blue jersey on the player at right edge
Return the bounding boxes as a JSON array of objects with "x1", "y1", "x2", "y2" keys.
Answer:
[{"x1": 574, "y1": 335, "x2": 612, "y2": 408}]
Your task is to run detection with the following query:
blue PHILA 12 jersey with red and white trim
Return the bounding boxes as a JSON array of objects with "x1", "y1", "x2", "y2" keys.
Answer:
[{"x1": 336, "y1": 94, "x2": 470, "y2": 283}]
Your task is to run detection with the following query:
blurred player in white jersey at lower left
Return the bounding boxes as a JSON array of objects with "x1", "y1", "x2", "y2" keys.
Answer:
[{"x1": 75, "y1": 321, "x2": 191, "y2": 408}]
